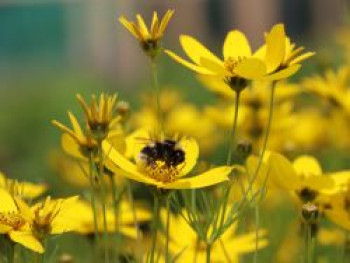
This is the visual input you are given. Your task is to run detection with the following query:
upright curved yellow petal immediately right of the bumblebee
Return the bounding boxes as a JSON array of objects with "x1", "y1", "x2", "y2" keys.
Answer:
[{"x1": 179, "y1": 138, "x2": 199, "y2": 176}]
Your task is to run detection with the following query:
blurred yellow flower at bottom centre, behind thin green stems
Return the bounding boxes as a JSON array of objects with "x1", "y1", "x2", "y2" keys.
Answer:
[{"x1": 161, "y1": 211, "x2": 268, "y2": 262}]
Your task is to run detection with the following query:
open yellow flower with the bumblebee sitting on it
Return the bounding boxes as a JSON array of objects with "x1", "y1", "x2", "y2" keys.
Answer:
[{"x1": 102, "y1": 132, "x2": 232, "y2": 189}]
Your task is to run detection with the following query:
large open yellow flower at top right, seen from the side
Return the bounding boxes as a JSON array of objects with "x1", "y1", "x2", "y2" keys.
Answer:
[{"x1": 165, "y1": 24, "x2": 308, "y2": 90}]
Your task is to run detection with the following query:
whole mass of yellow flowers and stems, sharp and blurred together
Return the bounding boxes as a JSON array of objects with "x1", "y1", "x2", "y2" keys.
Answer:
[{"x1": 0, "y1": 7, "x2": 350, "y2": 263}]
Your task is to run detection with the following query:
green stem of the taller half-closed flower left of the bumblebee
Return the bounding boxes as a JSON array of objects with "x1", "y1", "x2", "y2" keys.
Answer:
[{"x1": 98, "y1": 140, "x2": 109, "y2": 263}]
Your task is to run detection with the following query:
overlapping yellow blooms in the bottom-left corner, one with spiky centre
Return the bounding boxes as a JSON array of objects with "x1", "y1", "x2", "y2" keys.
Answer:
[{"x1": 0, "y1": 189, "x2": 78, "y2": 253}]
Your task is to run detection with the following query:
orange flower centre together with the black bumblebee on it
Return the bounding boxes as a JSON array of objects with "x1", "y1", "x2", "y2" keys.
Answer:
[{"x1": 139, "y1": 140, "x2": 185, "y2": 183}]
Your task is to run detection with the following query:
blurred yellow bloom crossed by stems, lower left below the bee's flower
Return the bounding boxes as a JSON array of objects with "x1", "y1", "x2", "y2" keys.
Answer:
[{"x1": 73, "y1": 201, "x2": 152, "y2": 238}]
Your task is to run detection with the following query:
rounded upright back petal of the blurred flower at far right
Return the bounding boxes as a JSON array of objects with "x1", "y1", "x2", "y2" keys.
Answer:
[{"x1": 293, "y1": 155, "x2": 322, "y2": 177}]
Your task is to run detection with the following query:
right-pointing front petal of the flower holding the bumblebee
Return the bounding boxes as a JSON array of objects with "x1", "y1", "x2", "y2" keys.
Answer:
[{"x1": 162, "y1": 166, "x2": 232, "y2": 189}]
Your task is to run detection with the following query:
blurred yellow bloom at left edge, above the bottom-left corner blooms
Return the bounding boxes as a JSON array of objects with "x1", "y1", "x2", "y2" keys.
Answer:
[{"x1": 0, "y1": 172, "x2": 47, "y2": 199}]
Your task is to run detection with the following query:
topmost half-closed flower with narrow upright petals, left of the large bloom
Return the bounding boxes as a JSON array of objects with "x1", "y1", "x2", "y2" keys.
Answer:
[{"x1": 119, "y1": 10, "x2": 174, "y2": 57}]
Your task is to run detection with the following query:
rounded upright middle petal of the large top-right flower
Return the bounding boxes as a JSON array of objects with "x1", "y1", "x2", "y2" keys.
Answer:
[{"x1": 223, "y1": 30, "x2": 252, "y2": 60}]
